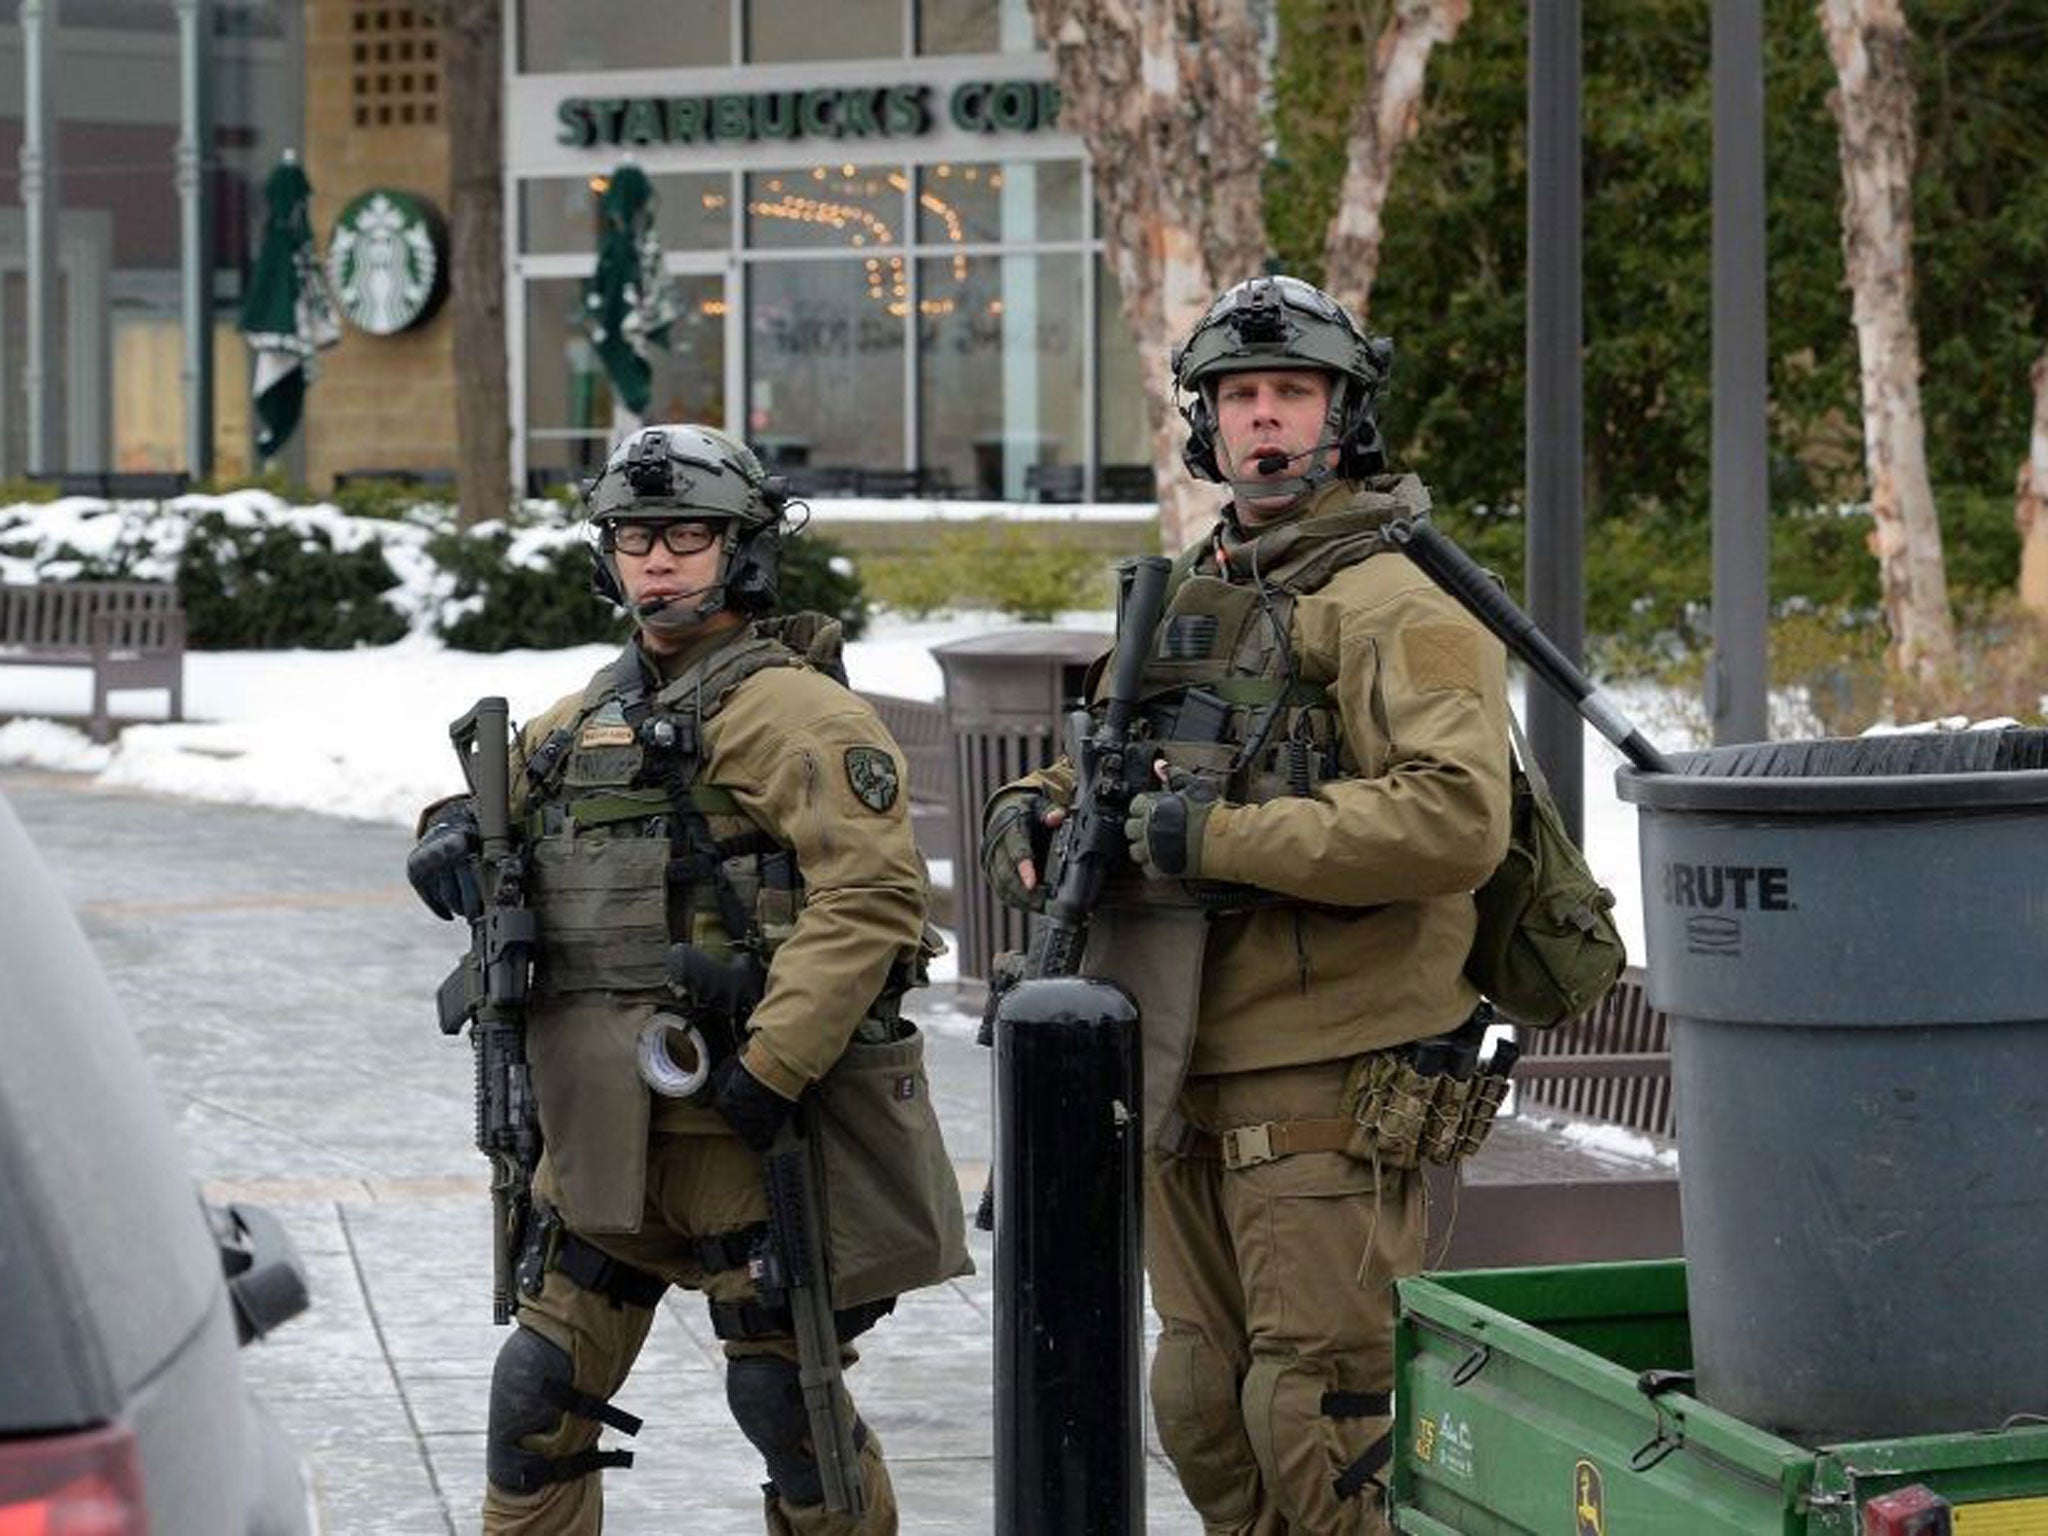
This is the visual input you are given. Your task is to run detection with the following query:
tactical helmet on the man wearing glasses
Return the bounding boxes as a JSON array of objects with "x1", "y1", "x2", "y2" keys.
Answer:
[{"x1": 584, "y1": 424, "x2": 788, "y2": 625}]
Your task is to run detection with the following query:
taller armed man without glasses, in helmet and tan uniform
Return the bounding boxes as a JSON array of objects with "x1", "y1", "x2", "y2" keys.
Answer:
[{"x1": 981, "y1": 276, "x2": 1509, "y2": 1536}]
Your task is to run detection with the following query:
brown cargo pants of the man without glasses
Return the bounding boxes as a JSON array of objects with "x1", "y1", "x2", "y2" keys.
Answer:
[{"x1": 1145, "y1": 1061, "x2": 1425, "y2": 1536}]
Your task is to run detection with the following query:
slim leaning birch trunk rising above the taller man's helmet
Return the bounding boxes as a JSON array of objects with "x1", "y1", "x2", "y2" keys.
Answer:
[{"x1": 1323, "y1": 0, "x2": 1473, "y2": 324}]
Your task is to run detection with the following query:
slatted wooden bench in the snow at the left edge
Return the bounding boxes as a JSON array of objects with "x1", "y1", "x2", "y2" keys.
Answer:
[{"x1": 0, "y1": 582, "x2": 184, "y2": 741}]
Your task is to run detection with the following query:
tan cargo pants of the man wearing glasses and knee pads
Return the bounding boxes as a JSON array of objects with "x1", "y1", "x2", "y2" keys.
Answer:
[{"x1": 483, "y1": 1133, "x2": 897, "y2": 1536}]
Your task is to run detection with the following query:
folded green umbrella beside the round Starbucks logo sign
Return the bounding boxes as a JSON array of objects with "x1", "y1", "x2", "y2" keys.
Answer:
[{"x1": 242, "y1": 150, "x2": 342, "y2": 459}]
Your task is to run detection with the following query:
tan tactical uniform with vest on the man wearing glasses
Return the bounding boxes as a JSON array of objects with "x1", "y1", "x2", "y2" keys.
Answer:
[{"x1": 483, "y1": 631, "x2": 926, "y2": 1536}]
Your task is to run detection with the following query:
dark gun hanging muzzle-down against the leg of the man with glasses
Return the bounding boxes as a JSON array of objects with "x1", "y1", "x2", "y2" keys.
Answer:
[{"x1": 754, "y1": 1110, "x2": 866, "y2": 1520}]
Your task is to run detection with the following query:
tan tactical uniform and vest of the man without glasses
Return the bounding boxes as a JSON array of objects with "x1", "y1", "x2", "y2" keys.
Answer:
[{"x1": 1003, "y1": 477, "x2": 1509, "y2": 1536}]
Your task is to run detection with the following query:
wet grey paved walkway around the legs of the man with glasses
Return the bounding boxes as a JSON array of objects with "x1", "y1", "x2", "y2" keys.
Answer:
[{"x1": 0, "y1": 770, "x2": 1200, "y2": 1536}]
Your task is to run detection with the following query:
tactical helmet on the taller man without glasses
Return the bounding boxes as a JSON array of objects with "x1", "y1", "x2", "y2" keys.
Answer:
[{"x1": 1169, "y1": 276, "x2": 1395, "y2": 481}]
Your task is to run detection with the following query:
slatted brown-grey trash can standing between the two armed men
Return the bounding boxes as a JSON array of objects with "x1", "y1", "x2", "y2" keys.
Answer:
[{"x1": 932, "y1": 629, "x2": 1114, "y2": 977}]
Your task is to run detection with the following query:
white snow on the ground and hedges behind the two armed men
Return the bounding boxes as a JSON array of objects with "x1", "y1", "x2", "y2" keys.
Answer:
[{"x1": 0, "y1": 492, "x2": 1662, "y2": 954}]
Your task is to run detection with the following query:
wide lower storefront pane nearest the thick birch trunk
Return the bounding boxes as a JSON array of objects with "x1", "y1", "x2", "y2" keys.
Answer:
[{"x1": 918, "y1": 256, "x2": 1087, "y2": 502}]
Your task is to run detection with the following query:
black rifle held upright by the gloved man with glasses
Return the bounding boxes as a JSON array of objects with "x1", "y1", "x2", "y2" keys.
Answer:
[{"x1": 438, "y1": 698, "x2": 541, "y2": 1323}]
